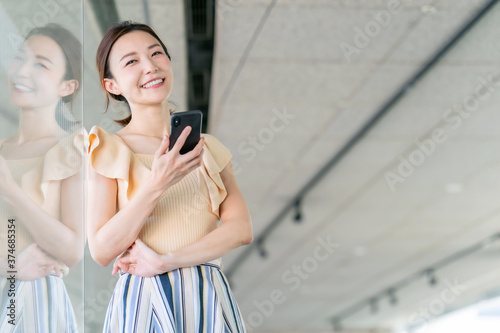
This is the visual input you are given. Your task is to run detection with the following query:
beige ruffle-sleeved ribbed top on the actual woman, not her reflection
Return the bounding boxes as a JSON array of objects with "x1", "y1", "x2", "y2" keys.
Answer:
[{"x1": 88, "y1": 126, "x2": 231, "y2": 254}]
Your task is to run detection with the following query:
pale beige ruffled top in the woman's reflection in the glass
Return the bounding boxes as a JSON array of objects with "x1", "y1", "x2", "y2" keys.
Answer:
[{"x1": 0, "y1": 132, "x2": 84, "y2": 275}]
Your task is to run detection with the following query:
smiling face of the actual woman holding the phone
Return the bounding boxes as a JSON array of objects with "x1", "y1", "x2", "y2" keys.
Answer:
[{"x1": 104, "y1": 31, "x2": 173, "y2": 106}]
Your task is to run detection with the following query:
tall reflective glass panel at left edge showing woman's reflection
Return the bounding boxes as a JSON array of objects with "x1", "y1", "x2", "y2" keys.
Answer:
[{"x1": 0, "y1": 0, "x2": 84, "y2": 332}]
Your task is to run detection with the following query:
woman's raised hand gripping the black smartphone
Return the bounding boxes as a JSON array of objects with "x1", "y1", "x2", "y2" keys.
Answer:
[{"x1": 151, "y1": 126, "x2": 205, "y2": 193}]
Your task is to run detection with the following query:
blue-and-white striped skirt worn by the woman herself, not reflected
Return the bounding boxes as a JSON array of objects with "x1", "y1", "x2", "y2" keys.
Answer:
[{"x1": 103, "y1": 260, "x2": 246, "y2": 333}]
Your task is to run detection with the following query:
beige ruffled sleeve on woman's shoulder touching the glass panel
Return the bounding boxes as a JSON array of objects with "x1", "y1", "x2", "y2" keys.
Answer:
[{"x1": 87, "y1": 126, "x2": 148, "y2": 200}]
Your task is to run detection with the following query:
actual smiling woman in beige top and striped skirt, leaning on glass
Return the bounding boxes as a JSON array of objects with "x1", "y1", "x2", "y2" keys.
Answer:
[{"x1": 87, "y1": 22, "x2": 252, "y2": 332}]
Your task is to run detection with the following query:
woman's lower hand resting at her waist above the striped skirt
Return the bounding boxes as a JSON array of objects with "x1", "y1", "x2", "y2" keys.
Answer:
[{"x1": 112, "y1": 239, "x2": 178, "y2": 277}]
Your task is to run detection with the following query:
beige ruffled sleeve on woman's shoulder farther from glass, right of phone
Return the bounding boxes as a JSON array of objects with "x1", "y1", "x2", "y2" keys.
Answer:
[{"x1": 202, "y1": 134, "x2": 232, "y2": 218}]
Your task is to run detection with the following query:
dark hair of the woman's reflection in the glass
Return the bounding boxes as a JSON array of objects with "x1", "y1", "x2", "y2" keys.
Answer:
[{"x1": 25, "y1": 23, "x2": 82, "y2": 130}]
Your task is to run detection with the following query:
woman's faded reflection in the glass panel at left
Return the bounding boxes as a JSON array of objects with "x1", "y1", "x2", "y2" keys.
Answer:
[{"x1": 0, "y1": 24, "x2": 84, "y2": 333}]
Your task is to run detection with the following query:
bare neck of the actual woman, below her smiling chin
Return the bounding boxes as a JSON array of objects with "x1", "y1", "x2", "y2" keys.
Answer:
[{"x1": 127, "y1": 101, "x2": 170, "y2": 139}]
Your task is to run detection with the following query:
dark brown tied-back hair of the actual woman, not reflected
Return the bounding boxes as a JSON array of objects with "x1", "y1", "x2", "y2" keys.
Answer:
[{"x1": 96, "y1": 21, "x2": 172, "y2": 126}]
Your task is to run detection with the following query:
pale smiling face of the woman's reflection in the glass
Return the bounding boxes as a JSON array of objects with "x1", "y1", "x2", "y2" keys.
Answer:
[{"x1": 9, "y1": 35, "x2": 66, "y2": 109}]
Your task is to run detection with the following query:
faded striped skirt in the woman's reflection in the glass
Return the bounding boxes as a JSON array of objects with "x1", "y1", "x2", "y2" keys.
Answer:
[{"x1": 0, "y1": 274, "x2": 78, "y2": 333}]
